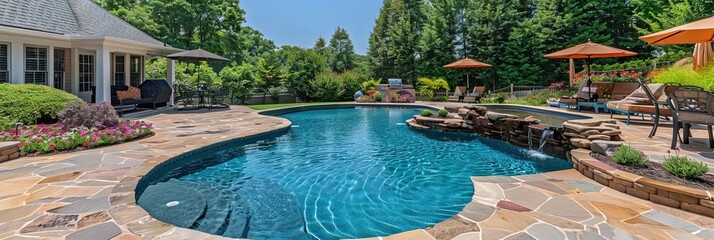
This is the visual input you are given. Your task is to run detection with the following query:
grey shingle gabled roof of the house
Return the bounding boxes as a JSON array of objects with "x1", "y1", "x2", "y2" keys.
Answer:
[{"x1": 0, "y1": 0, "x2": 164, "y2": 46}]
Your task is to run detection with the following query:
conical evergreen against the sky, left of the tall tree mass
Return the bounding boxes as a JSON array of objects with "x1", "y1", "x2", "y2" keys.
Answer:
[{"x1": 328, "y1": 27, "x2": 355, "y2": 73}]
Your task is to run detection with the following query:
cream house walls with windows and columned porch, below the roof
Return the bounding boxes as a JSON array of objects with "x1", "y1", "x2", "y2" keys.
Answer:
[{"x1": 0, "y1": 26, "x2": 182, "y2": 104}]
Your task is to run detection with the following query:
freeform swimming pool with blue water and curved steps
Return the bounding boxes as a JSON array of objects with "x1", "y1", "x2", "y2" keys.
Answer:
[{"x1": 138, "y1": 107, "x2": 571, "y2": 239}]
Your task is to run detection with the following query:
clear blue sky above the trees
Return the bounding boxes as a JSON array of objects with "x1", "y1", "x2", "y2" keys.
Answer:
[{"x1": 240, "y1": 0, "x2": 382, "y2": 54}]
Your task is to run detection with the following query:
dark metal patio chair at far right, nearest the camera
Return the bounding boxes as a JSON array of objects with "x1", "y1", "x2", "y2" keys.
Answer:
[{"x1": 668, "y1": 87, "x2": 714, "y2": 149}]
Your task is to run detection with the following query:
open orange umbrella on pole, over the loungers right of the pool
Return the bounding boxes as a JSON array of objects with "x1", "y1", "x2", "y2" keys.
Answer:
[{"x1": 545, "y1": 40, "x2": 637, "y2": 96}]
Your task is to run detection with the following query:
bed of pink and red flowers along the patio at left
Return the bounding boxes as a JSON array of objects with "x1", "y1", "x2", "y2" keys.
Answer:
[{"x1": 0, "y1": 121, "x2": 153, "y2": 156}]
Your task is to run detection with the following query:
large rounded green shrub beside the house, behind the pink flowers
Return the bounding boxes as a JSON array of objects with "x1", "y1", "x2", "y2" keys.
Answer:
[{"x1": 0, "y1": 84, "x2": 82, "y2": 130}]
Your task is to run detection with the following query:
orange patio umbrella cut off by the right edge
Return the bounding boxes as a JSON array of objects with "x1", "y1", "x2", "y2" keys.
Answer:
[{"x1": 640, "y1": 17, "x2": 714, "y2": 70}]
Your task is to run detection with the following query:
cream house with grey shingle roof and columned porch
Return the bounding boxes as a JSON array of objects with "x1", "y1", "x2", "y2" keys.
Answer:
[{"x1": 0, "y1": 0, "x2": 182, "y2": 103}]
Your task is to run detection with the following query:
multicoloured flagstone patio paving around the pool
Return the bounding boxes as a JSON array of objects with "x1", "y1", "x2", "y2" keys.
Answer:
[{"x1": 0, "y1": 103, "x2": 714, "y2": 239}]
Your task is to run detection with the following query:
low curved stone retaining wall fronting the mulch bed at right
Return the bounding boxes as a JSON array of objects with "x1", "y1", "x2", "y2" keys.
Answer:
[{"x1": 570, "y1": 149, "x2": 714, "y2": 217}]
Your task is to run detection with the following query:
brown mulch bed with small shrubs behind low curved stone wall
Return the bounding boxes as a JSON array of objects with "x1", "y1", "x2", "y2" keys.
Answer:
[{"x1": 590, "y1": 152, "x2": 714, "y2": 190}]
